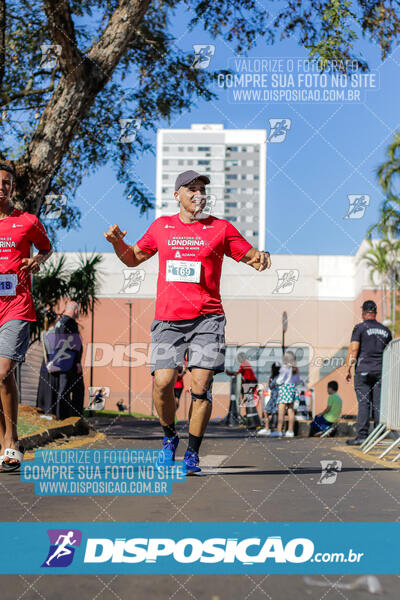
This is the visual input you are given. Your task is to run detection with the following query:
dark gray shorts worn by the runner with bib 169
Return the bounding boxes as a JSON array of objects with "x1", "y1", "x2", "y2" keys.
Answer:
[{"x1": 150, "y1": 314, "x2": 226, "y2": 375}]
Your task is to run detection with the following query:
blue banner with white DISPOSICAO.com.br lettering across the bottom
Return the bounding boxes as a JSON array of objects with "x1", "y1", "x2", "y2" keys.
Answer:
[{"x1": 0, "y1": 522, "x2": 400, "y2": 575}]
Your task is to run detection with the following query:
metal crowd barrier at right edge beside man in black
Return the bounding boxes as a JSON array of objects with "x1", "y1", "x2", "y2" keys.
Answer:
[{"x1": 361, "y1": 338, "x2": 400, "y2": 461}]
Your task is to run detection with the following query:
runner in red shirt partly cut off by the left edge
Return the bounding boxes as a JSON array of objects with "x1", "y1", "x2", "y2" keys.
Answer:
[{"x1": 0, "y1": 163, "x2": 52, "y2": 473}]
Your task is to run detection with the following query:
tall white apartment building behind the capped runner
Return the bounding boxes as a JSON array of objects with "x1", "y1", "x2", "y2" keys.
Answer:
[{"x1": 156, "y1": 124, "x2": 267, "y2": 250}]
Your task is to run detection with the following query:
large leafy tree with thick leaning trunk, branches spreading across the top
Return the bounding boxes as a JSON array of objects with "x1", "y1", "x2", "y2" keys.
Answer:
[{"x1": 0, "y1": 0, "x2": 400, "y2": 229}]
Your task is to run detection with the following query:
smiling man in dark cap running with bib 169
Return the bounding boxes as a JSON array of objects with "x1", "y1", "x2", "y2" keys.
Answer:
[{"x1": 104, "y1": 171, "x2": 271, "y2": 474}]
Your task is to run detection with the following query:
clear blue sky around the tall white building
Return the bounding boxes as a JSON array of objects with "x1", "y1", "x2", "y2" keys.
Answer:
[{"x1": 57, "y1": 11, "x2": 400, "y2": 254}]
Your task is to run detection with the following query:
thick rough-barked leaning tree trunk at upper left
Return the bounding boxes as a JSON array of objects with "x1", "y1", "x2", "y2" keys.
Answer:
[{"x1": 15, "y1": 0, "x2": 150, "y2": 214}]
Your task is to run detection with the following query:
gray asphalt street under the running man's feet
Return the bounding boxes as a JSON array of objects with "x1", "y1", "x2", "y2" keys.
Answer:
[{"x1": 0, "y1": 419, "x2": 400, "y2": 600}]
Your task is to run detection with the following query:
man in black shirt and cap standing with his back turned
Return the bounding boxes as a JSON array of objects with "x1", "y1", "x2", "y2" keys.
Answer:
[{"x1": 346, "y1": 300, "x2": 392, "y2": 446}]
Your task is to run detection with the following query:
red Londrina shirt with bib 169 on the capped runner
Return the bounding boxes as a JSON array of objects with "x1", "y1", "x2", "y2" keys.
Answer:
[{"x1": 137, "y1": 215, "x2": 252, "y2": 321}]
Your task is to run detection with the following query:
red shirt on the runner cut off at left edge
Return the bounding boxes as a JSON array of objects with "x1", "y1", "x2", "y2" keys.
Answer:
[{"x1": 0, "y1": 208, "x2": 51, "y2": 327}]
